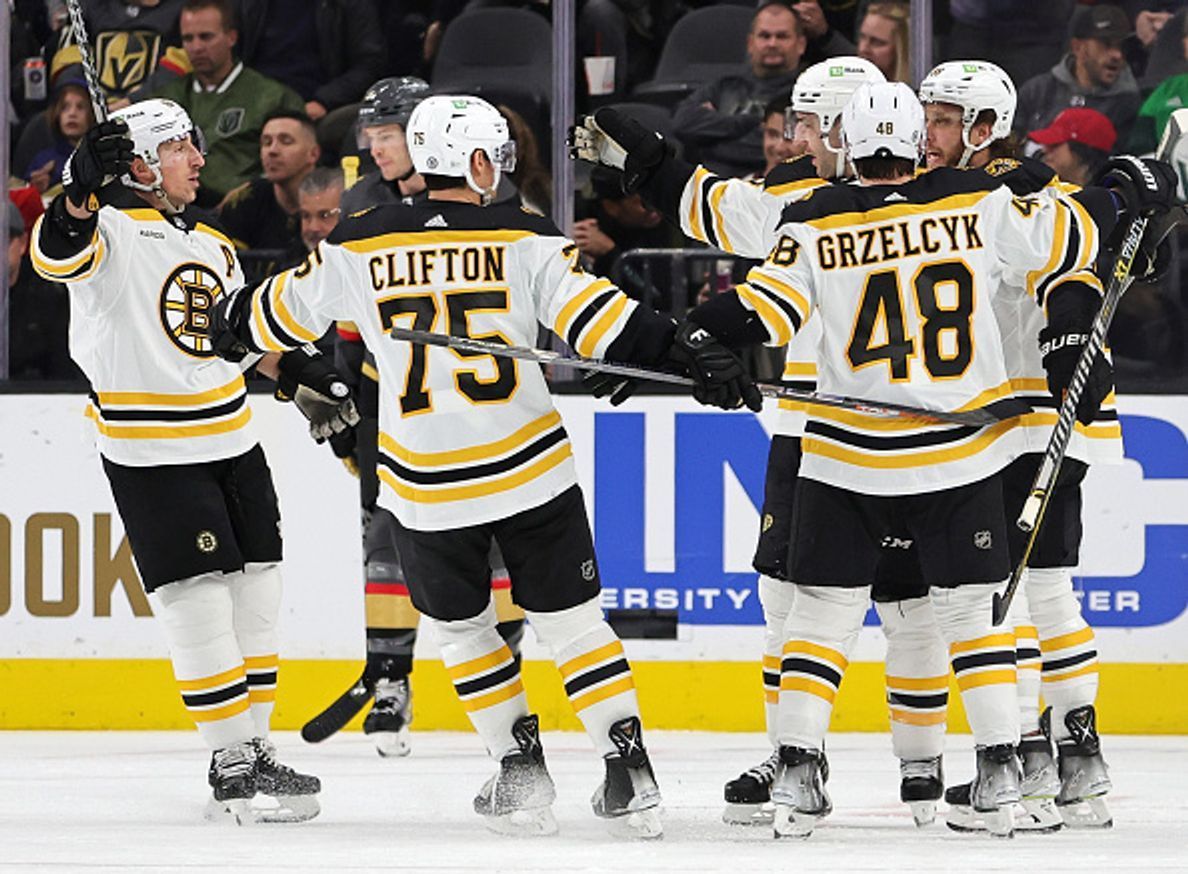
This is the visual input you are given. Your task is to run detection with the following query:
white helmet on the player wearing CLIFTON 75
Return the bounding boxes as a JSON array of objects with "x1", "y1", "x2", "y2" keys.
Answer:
[{"x1": 407, "y1": 94, "x2": 516, "y2": 203}]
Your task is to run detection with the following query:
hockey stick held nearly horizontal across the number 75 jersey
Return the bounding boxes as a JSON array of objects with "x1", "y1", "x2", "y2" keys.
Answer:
[{"x1": 388, "y1": 327, "x2": 1031, "y2": 428}]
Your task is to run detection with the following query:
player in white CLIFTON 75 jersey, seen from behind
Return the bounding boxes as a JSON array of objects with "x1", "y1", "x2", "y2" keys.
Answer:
[{"x1": 205, "y1": 95, "x2": 760, "y2": 837}]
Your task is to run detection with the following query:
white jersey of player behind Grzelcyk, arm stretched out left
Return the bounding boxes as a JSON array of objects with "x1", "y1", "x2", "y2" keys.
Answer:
[{"x1": 680, "y1": 156, "x2": 829, "y2": 437}]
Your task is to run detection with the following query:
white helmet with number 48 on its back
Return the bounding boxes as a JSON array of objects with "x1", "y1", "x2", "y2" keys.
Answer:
[{"x1": 841, "y1": 82, "x2": 924, "y2": 167}]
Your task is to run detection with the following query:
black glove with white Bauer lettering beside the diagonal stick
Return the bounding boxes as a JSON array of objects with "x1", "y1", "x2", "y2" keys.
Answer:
[{"x1": 1040, "y1": 285, "x2": 1113, "y2": 425}]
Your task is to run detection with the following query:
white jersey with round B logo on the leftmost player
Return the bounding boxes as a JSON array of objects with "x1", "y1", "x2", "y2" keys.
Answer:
[{"x1": 30, "y1": 195, "x2": 257, "y2": 467}]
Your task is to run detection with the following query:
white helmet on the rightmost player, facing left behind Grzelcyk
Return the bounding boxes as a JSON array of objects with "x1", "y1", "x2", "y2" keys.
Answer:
[{"x1": 920, "y1": 61, "x2": 1018, "y2": 167}]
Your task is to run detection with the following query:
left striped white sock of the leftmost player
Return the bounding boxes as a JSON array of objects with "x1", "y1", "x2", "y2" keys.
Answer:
[{"x1": 149, "y1": 574, "x2": 255, "y2": 749}]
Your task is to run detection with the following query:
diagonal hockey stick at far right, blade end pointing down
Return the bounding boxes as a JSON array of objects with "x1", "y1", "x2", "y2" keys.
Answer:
[{"x1": 992, "y1": 119, "x2": 1188, "y2": 625}]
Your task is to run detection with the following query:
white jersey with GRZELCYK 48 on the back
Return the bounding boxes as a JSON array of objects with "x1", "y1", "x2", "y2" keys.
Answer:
[{"x1": 738, "y1": 170, "x2": 1098, "y2": 495}]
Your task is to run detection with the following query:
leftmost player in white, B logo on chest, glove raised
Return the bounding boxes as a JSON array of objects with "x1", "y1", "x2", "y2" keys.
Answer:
[{"x1": 32, "y1": 100, "x2": 345, "y2": 822}]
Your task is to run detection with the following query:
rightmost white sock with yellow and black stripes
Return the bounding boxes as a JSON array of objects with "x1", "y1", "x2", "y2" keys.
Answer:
[{"x1": 1028, "y1": 568, "x2": 1098, "y2": 740}]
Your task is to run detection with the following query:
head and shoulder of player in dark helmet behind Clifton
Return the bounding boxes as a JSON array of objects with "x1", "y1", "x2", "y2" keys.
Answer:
[{"x1": 342, "y1": 76, "x2": 429, "y2": 215}]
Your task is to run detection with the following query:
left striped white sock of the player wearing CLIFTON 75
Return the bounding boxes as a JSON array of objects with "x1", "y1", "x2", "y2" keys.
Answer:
[{"x1": 431, "y1": 602, "x2": 527, "y2": 761}]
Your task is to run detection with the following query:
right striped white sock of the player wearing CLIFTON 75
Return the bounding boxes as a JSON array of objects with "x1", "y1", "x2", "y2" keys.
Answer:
[{"x1": 527, "y1": 597, "x2": 639, "y2": 756}]
